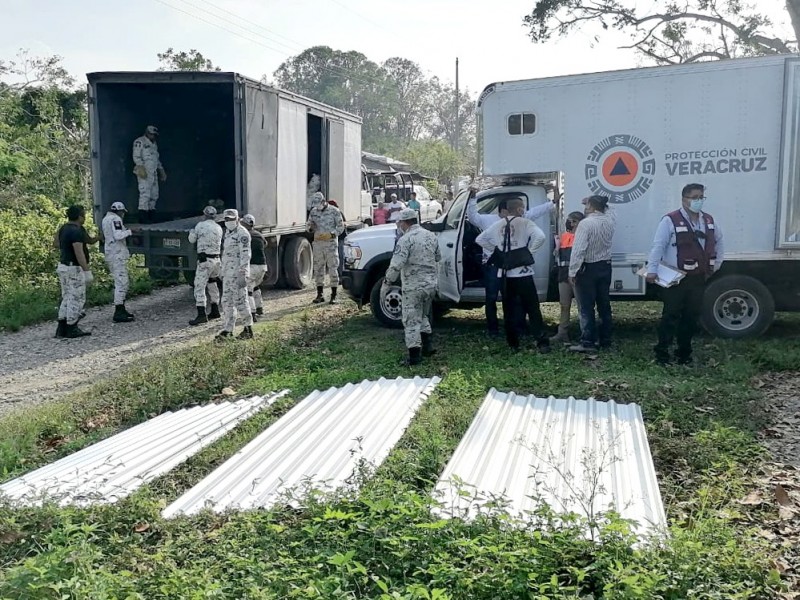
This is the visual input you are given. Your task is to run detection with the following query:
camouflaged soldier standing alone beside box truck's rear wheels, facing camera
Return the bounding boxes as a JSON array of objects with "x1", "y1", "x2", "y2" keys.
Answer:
[{"x1": 307, "y1": 192, "x2": 344, "y2": 304}]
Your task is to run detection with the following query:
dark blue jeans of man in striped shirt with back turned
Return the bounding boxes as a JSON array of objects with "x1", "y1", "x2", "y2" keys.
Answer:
[{"x1": 575, "y1": 261, "x2": 612, "y2": 348}]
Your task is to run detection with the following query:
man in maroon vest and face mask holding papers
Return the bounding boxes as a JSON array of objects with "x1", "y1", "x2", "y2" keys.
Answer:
[{"x1": 647, "y1": 183, "x2": 724, "y2": 365}]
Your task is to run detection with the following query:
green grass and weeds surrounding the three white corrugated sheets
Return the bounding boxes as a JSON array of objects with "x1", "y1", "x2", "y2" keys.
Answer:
[{"x1": 0, "y1": 304, "x2": 800, "y2": 600}]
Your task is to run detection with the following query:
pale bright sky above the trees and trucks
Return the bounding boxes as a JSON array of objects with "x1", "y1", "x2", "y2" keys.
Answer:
[{"x1": 0, "y1": 0, "x2": 788, "y2": 94}]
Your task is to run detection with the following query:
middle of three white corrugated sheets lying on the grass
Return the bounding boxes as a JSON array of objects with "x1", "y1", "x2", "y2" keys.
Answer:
[{"x1": 162, "y1": 377, "x2": 440, "y2": 518}]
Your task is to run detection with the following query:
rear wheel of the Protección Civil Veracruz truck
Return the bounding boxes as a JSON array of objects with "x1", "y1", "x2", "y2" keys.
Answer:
[{"x1": 702, "y1": 275, "x2": 775, "y2": 339}]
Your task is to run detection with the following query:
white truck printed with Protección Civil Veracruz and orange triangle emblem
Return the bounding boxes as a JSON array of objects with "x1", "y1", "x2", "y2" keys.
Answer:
[{"x1": 343, "y1": 55, "x2": 800, "y2": 338}]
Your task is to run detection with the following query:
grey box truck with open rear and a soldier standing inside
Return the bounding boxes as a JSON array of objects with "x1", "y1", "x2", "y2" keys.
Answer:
[{"x1": 87, "y1": 72, "x2": 370, "y2": 289}]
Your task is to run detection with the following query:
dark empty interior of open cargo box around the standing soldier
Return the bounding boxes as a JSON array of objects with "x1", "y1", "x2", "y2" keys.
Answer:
[{"x1": 93, "y1": 82, "x2": 237, "y2": 221}]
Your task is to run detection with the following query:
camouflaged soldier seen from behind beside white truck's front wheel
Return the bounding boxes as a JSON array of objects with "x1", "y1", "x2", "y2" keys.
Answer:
[{"x1": 381, "y1": 208, "x2": 441, "y2": 366}]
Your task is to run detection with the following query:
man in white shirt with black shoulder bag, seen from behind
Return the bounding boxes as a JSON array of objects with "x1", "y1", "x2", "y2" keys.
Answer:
[{"x1": 475, "y1": 198, "x2": 550, "y2": 353}]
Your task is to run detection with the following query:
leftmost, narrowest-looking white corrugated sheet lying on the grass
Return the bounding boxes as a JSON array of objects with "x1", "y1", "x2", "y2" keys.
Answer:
[{"x1": 0, "y1": 390, "x2": 288, "y2": 505}]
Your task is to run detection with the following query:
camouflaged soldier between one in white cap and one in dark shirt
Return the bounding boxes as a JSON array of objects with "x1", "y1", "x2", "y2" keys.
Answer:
[{"x1": 217, "y1": 208, "x2": 253, "y2": 340}]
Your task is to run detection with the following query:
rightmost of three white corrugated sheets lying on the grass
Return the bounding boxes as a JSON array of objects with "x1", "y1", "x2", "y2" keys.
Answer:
[{"x1": 434, "y1": 389, "x2": 666, "y2": 534}]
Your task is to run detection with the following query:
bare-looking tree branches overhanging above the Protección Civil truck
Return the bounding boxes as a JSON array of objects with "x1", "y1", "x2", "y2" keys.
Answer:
[{"x1": 524, "y1": 0, "x2": 800, "y2": 65}]
